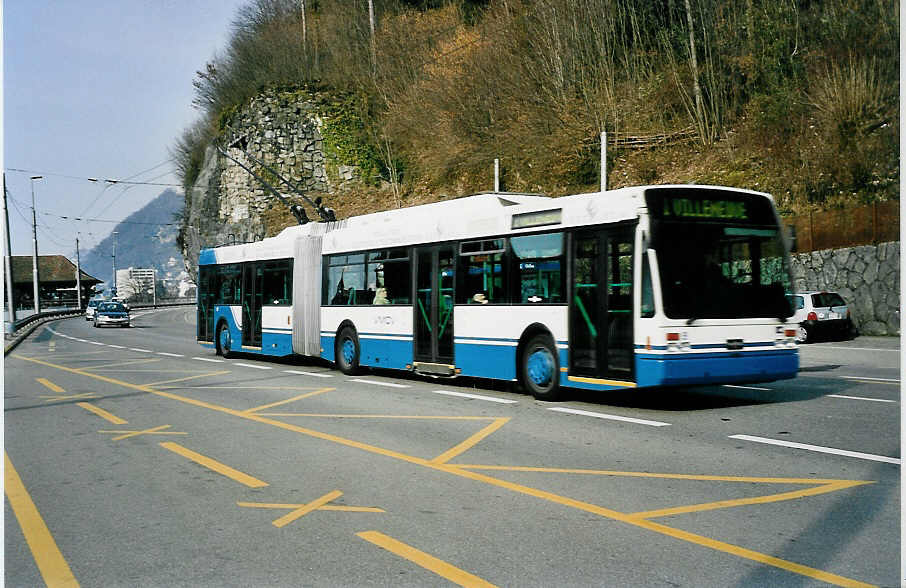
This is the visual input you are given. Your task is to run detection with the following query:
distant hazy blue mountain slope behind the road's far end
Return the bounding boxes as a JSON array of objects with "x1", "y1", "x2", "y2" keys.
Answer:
[{"x1": 81, "y1": 189, "x2": 184, "y2": 282}]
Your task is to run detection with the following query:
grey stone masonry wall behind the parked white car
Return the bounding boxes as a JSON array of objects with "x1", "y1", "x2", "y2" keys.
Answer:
[{"x1": 791, "y1": 242, "x2": 900, "y2": 335}]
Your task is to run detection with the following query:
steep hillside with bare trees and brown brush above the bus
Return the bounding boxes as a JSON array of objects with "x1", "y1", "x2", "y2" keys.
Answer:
[{"x1": 173, "y1": 0, "x2": 899, "y2": 238}]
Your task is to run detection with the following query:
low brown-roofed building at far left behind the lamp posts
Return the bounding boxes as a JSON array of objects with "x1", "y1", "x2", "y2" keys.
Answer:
[{"x1": 4, "y1": 255, "x2": 102, "y2": 310}]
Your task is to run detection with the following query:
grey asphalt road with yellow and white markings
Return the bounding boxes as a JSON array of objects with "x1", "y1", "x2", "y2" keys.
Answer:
[{"x1": 4, "y1": 308, "x2": 901, "y2": 586}]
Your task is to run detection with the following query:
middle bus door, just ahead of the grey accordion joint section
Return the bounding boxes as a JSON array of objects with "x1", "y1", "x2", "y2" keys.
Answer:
[{"x1": 413, "y1": 245, "x2": 456, "y2": 373}]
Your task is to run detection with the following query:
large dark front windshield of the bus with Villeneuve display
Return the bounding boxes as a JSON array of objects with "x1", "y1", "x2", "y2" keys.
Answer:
[{"x1": 649, "y1": 188, "x2": 792, "y2": 323}]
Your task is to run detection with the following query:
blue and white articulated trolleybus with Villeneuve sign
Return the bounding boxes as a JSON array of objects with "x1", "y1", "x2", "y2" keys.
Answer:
[{"x1": 198, "y1": 186, "x2": 799, "y2": 400}]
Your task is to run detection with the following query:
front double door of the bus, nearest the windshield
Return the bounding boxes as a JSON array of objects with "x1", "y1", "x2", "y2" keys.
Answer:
[{"x1": 569, "y1": 228, "x2": 635, "y2": 381}]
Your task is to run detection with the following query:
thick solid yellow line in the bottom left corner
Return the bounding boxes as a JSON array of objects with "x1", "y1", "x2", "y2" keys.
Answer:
[{"x1": 3, "y1": 451, "x2": 79, "y2": 588}]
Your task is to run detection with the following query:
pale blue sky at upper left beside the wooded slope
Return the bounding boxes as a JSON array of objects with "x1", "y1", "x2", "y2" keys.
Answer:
[{"x1": 2, "y1": 0, "x2": 248, "y2": 257}]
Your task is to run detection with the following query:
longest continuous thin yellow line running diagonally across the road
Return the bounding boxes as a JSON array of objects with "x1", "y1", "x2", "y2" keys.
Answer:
[{"x1": 13, "y1": 354, "x2": 870, "y2": 586}]
